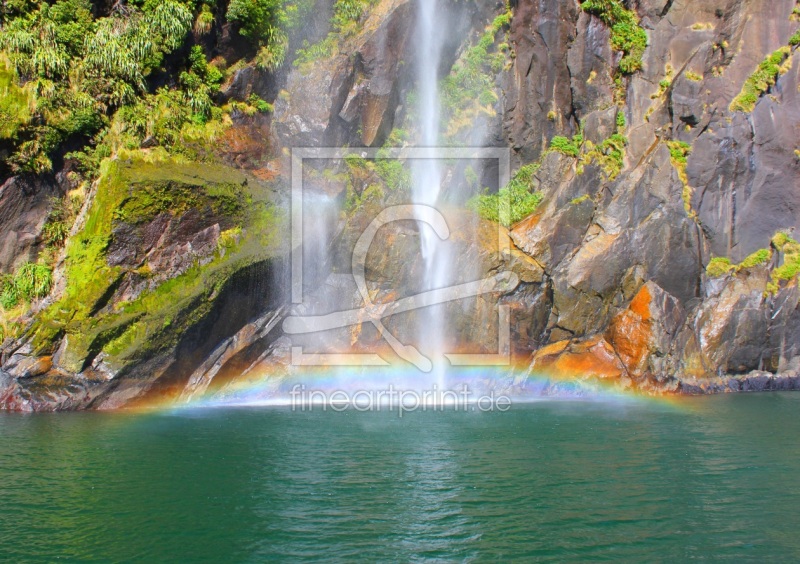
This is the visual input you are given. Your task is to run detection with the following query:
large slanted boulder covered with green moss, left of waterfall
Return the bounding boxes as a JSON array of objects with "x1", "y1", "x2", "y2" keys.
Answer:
[{"x1": 28, "y1": 155, "x2": 280, "y2": 373}]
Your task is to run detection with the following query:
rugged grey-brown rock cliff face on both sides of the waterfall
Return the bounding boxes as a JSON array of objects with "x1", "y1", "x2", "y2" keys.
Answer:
[{"x1": 0, "y1": 0, "x2": 800, "y2": 409}]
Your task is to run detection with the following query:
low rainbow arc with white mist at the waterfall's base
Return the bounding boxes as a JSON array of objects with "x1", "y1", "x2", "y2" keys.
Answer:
[{"x1": 126, "y1": 363, "x2": 689, "y2": 411}]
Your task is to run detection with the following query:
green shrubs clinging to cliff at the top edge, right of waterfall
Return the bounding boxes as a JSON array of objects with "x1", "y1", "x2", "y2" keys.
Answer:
[{"x1": 581, "y1": 0, "x2": 647, "y2": 74}]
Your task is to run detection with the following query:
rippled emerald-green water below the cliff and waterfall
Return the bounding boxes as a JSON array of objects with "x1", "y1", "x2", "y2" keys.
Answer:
[{"x1": 0, "y1": 393, "x2": 800, "y2": 562}]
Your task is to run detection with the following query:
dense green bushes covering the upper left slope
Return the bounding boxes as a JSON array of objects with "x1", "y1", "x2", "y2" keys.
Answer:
[{"x1": 0, "y1": 0, "x2": 304, "y2": 177}]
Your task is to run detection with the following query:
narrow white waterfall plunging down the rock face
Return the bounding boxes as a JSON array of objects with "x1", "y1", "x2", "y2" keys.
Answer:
[{"x1": 412, "y1": 0, "x2": 451, "y2": 389}]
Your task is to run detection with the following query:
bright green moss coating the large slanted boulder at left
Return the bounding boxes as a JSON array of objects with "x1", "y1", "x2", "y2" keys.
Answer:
[{"x1": 30, "y1": 156, "x2": 264, "y2": 364}]
